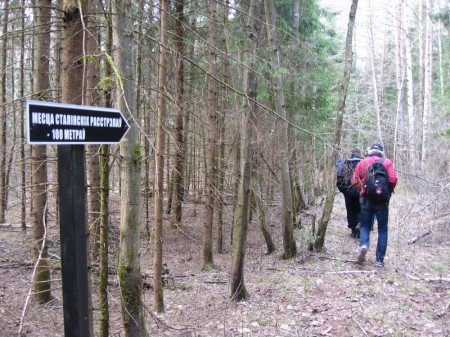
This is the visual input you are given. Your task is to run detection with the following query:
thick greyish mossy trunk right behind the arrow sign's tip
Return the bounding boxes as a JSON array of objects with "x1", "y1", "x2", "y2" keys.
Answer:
[{"x1": 111, "y1": 0, "x2": 147, "y2": 337}]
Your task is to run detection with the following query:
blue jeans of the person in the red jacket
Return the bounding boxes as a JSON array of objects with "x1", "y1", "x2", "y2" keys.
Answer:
[{"x1": 359, "y1": 198, "x2": 389, "y2": 262}]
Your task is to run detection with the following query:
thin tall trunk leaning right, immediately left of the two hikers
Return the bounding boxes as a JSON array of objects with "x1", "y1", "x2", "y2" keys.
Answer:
[{"x1": 310, "y1": 0, "x2": 358, "y2": 250}]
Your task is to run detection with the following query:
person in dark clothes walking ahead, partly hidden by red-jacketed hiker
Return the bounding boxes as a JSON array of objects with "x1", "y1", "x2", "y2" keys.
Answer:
[{"x1": 336, "y1": 147, "x2": 362, "y2": 238}]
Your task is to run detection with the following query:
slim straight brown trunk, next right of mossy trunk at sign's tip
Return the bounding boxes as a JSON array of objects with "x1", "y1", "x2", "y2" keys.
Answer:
[{"x1": 153, "y1": 0, "x2": 169, "y2": 312}]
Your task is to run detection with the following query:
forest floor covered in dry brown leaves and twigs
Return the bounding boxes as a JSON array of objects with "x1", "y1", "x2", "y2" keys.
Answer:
[{"x1": 0, "y1": 185, "x2": 450, "y2": 337}]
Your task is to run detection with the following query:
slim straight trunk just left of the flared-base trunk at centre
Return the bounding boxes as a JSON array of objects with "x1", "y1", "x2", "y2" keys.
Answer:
[{"x1": 202, "y1": 0, "x2": 217, "y2": 270}]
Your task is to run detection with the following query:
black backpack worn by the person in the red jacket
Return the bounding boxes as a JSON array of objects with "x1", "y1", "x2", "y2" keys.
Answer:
[{"x1": 364, "y1": 158, "x2": 391, "y2": 205}]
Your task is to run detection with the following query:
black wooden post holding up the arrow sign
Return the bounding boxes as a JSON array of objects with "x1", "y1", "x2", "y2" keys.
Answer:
[{"x1": 58, "y1": 145, "x2": 89, "y2": 337}]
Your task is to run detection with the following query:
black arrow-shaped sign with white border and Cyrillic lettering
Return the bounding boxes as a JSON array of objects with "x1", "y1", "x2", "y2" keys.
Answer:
[{"x1": 26, "y1": 100, "x2": 130, "y2": 144}]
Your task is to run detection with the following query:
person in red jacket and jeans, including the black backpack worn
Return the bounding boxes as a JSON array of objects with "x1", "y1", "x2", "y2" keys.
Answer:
[{"x1": 352, "y1": 143, "x2": 397, "y2": 267}]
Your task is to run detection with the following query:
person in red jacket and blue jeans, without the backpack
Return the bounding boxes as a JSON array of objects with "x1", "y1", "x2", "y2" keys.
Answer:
[{"x1": 352, "y1": 143, "x2": 397, "y2": 267}]
